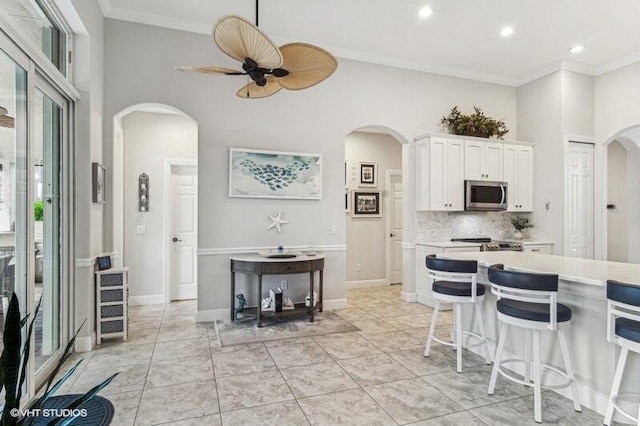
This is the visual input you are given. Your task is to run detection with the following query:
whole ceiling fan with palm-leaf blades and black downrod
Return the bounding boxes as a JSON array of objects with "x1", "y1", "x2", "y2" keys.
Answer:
[{"x1": 176, "y1": 0, "x2": 338, "y2": 99}]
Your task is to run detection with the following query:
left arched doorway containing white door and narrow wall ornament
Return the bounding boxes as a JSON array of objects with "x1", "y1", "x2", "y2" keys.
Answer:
[{"x1": 111, "y1": 104, "x2": 198, "y2": 305}]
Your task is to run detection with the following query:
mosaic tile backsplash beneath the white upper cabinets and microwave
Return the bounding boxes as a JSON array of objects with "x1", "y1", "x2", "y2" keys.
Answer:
[{"x1": 416, "y1": 212, "x2": 530, "y2": 242}]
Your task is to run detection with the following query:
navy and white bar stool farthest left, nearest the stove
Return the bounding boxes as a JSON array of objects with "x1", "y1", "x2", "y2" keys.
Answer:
[{"x1": 424, "y1": 254, "x2": 491, "y2": 373}]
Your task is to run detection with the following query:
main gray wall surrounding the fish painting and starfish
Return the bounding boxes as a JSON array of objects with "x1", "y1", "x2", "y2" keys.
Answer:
[{"x1": 104, "y1": 19, "x2": 518, "y2": 317}]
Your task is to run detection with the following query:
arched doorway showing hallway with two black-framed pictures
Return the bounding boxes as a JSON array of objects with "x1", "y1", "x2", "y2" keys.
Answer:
[{"x1": 345, "y1": 126, "x2": 413, "y2": 288}]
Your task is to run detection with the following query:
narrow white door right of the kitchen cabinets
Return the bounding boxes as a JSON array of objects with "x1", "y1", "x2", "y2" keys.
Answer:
[{"x1": 567, "y1": 142, "x2": 594, "y2": 259}]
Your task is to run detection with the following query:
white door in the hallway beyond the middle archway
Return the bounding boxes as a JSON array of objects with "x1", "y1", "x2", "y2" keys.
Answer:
[{"x1": 386, "y1": 171, "x2": 402, "y2": 284}]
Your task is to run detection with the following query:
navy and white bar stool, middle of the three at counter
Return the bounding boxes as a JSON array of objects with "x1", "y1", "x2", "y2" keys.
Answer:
[{"x1": 488, "y1": 265, "x2": 582, "y2": 423}]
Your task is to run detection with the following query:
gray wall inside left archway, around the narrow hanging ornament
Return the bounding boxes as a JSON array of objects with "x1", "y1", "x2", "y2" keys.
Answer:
[{"x1": 122, "y1": 112, "x2": 198, "y2": 304}]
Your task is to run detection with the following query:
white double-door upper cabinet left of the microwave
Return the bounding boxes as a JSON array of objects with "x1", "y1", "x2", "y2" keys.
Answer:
[{"x1": 416, "y1": 137, "x2": 464, "y2": 211}]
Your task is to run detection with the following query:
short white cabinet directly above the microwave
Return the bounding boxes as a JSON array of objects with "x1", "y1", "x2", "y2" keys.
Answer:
[{"x1": 464, "y1": 140, "x2": 504, "y2": 181}]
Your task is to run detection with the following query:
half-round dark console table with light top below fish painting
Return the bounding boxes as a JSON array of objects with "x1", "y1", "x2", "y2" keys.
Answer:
[{"x1": 230, "y1": 254, "x2": 324, "y2": 327}]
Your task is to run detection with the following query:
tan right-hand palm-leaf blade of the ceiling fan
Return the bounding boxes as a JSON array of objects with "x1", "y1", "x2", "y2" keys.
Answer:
[{"x1": 276, "y1": 43, "x2": 338, "y2": 90}]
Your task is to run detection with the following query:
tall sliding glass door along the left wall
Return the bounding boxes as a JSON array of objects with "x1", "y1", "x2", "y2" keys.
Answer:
[{"x1": 0, "y1": 31, "x2": 73, "y2": 396}]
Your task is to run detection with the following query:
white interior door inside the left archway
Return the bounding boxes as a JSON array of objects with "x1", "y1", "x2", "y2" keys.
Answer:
[{"x1": 168, "y1": 166, "x2": 198, "y2": 302}]
